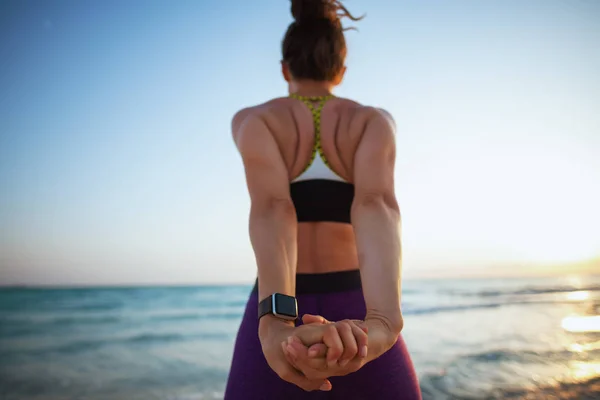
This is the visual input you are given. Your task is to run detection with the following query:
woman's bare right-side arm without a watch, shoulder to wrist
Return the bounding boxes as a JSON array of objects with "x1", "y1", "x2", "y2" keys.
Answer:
[{"x1": 352, "y1": 111, "x2": 403, "y2": 360}]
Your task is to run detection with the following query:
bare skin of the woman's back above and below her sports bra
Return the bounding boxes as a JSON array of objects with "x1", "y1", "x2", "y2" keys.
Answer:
[{"x1": 233, "y1": 97, "x2": 377, "y2": 273}]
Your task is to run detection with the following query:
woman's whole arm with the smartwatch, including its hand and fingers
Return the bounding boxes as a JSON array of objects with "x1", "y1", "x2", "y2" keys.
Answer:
[{"x1": 232, "y1": 110, "x2": 367, "y2": 390}]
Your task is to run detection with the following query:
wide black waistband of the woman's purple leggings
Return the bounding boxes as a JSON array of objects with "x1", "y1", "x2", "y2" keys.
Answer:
[{"x1": 252, "y1": 269, "x2": 362, "y2": 296}]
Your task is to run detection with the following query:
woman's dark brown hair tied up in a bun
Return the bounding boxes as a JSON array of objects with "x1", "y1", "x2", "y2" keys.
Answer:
[{"x1": 281, "y1": 0, "x2": 363, "y2": 81}]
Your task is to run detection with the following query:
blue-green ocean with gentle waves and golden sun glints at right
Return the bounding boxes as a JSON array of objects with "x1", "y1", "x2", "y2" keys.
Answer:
[{"x1": 0, "y1": 276, "x2": 600, "y2": 400}]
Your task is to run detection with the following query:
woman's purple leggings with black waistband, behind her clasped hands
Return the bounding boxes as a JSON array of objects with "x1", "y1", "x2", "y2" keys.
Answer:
[{"x1": 225, "y1": 270, "x2": 421, "y2": 400}]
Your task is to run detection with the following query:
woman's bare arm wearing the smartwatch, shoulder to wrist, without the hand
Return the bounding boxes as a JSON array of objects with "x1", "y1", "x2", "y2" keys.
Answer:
[{"x1": 233, "y1": 111, "x2": 297, "y2": 333}]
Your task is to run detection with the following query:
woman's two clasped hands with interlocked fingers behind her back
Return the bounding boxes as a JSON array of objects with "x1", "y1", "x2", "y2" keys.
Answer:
[{"x1": 261, "y1": 314, "x2": 368, "y2": 391}]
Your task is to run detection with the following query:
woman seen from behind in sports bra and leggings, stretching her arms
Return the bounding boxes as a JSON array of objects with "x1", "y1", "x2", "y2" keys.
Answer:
[{"x1": 225, "y1": 0, "x2": 420, "y2": 400}]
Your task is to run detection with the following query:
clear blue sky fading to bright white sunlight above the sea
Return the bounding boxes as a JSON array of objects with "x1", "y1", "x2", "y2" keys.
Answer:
[{"x1": 0, "y1": 0, "x2": 600, "y2": 285}]
